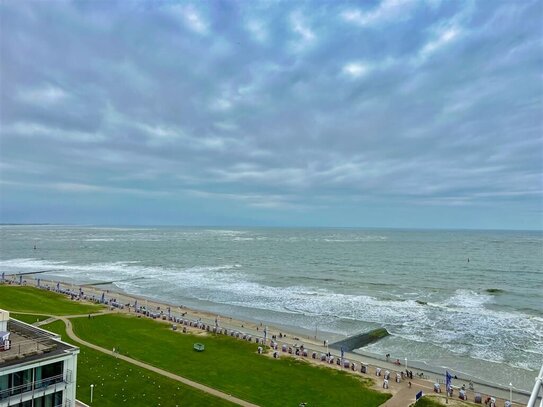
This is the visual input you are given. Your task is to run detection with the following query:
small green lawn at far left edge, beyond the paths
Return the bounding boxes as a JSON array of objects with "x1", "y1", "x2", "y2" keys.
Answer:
[{"x1": 0, "y1": 285, "x2": 104, "y2": 315}]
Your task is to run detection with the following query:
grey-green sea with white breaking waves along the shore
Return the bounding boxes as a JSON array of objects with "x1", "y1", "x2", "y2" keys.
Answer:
[{"x1": 0, "y1": 226, "x2": 543, "y2": 390}]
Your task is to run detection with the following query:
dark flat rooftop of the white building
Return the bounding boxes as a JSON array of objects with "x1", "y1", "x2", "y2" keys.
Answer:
[{"x1": 0, "y1": 319, "x2": 78, "y2": 368}]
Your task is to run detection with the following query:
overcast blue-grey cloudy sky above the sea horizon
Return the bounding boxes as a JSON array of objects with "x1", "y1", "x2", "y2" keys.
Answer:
[{"x1": 0, "y1": 0, "x2": 543, "y2": 229}]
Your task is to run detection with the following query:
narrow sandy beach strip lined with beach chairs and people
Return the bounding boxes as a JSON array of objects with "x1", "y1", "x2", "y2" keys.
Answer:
[{"x1": 8, "y1": 276, "x2": 529, "y2": 406}]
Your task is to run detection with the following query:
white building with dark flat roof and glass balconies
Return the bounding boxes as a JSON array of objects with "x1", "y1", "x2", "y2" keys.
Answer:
[{"x1": 0, "y1": 310, "x2": 79, "y2": 407}]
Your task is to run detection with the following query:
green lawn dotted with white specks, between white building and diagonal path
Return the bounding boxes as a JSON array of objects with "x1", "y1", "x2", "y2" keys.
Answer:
[{"x1": 43, "y1": 321, "x2": 234, "y2": 407}]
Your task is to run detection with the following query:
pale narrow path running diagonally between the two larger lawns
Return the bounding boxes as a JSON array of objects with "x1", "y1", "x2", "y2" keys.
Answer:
[{"x1": 58, "y1": 317, "x2": 258, "y2": 407}]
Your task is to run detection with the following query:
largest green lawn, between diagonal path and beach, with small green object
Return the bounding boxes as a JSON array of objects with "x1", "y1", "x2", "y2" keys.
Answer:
[{"x1": 72, "y1": 314, "x2": 390, "y2": 407}]
